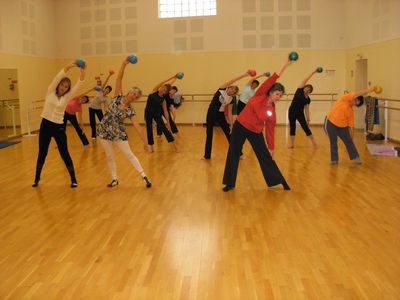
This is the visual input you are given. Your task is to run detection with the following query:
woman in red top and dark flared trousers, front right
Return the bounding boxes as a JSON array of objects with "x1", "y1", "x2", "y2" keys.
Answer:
[{"x1": 223, "y1": 60, "x2": 293, "y2": 192}]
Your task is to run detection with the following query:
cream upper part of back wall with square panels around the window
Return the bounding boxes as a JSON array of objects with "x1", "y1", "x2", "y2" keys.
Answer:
[{"x1": 56, "y1": 0, "x2": 346, "y2": 58}]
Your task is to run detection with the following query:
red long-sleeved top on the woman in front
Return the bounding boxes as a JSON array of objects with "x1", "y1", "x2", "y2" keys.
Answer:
[{"x1": 237, "y1": 73, "x2": 279, "y2": 133}]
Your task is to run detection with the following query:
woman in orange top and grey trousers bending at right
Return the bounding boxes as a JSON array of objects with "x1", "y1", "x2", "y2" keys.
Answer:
[{"x1": 325, "y1": 87, "x2": 375, "y2": 164}]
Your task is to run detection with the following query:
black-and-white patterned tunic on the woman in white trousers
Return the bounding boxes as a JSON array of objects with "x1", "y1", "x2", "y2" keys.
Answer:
[{"x1": 97, "y1": 94, "x2": 135, "y2": 141}]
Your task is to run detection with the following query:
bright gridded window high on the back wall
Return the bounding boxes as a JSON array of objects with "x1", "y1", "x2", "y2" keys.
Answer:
[{"x1": 158, "y1": 0, "x2": 217, "y2": 18}]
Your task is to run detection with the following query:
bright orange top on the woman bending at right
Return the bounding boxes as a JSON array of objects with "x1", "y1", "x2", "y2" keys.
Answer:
[{"x1": 327, "y1": 93, "x2": 354, "y2": 127}]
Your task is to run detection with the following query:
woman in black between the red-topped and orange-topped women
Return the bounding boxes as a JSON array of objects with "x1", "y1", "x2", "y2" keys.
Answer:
[{"x1": 288, "y1": 71, "x2": 317, "y2": 148}]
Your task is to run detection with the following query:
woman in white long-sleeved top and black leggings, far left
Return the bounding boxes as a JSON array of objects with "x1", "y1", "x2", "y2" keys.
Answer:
[{"x1": 32, "y1": 63, "x2": 85, "y2": 188}]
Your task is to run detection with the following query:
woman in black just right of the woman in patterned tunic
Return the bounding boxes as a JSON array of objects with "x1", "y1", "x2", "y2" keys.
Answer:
[{"x1": 144, "y1": 75, "x2": 177, "y2": 152}]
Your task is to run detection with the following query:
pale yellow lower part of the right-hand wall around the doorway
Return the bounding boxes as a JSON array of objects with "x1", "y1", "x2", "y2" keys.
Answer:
[{"x1": 346, "y1": 39, "x2": 400, "y2": 140}]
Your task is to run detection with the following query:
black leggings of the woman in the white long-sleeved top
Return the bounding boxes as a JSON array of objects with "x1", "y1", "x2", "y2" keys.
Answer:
[{"x1": 35, "y1": 119, "x2": 76, "y2": 182}]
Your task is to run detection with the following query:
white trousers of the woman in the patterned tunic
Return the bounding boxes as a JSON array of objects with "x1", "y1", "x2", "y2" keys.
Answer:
[{"x1": 100, "y1": 139, "x2": 146, "y2": 179}]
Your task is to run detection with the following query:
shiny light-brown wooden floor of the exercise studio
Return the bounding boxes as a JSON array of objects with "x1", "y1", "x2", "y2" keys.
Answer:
[{"x1": 0, "y1": 126, "x2": 400, "y2": 300}]
